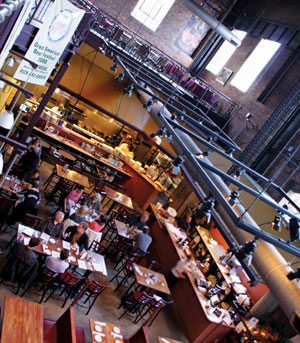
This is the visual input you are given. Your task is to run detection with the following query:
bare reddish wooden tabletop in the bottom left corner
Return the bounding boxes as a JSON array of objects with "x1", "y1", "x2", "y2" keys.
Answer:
[{"x1": 1, "y1": 295, "x2": 43, "y2": 343}]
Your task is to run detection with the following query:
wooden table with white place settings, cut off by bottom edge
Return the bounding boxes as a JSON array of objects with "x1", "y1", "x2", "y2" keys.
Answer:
[{"x1": 90, "y1": 319, "x2": 124, "y2": 343}]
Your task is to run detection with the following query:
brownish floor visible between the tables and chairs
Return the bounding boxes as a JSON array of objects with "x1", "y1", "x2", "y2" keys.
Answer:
[{"x1": 0, "y1": 163, "x2": 189, "y2": 343}]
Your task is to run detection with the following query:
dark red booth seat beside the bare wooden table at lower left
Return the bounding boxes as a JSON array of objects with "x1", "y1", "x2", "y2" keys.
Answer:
[{"x1": 43, "y1": 306, "x2": 85, "y2": 343}]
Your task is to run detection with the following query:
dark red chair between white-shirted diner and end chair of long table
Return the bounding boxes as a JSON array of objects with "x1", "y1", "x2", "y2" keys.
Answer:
[{"x1": 45, "y1": 272, "x2": 84, "y2": 307}]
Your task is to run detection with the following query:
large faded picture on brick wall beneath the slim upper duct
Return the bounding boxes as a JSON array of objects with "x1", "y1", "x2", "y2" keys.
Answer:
[{"x1": 174, "y1": 15, "x2": 209, "y2": 56}]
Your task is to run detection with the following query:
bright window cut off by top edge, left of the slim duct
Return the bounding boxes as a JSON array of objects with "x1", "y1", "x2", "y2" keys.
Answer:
[{"x1": 131, "y1": 0, "x2": 175, "y2": 32}]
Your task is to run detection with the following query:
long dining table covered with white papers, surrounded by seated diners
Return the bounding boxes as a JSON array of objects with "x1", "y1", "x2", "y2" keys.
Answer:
[{"x1": 17, "y1": 224, "x2": 107, "y2": 277}]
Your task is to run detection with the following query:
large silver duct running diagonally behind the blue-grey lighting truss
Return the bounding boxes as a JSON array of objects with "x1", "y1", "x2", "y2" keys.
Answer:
[{"x1": 138, "y1": 90, "x2": 300, "y2": 319}]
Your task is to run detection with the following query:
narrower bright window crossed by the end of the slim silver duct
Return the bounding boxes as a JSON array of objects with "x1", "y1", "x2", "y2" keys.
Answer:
[{"x1": 205, "y1": 30, "x2": 247, "y2": 75}]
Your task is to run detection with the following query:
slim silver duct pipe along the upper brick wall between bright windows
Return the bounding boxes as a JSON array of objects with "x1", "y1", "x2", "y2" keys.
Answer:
[{"x1": 179, "y1": 0, "x2": 241, "y2": 46}]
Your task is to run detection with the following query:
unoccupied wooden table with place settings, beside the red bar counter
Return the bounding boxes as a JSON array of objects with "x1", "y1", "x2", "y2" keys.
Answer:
[{"x1": 133, "y1": 263, "x2": 171, "y2": 294}]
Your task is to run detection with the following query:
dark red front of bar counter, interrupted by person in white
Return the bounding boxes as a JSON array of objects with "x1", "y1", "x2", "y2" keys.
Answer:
[{"x1": 149, "y1": 205, "x2": 233, "y2": 343}]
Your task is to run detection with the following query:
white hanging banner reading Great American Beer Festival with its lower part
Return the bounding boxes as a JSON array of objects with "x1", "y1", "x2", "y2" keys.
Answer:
[{"x1": 14, "y1": 0, "x2": 85, "y2": 86}]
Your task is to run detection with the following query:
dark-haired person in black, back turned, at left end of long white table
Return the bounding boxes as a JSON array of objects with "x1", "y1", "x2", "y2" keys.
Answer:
[{"x1": 0, "y1": 235, "x2": 40, "y2": 289}]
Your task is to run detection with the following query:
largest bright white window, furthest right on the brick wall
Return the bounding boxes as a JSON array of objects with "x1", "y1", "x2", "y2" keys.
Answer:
[{"x1": 231, "y1": 39, "x2": 280, "y2": 93}]
